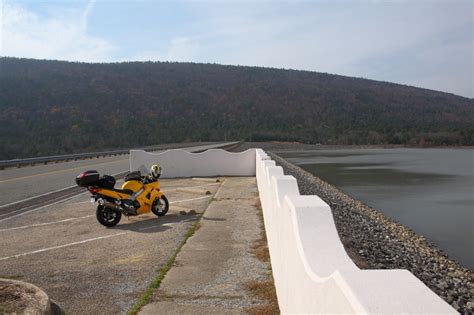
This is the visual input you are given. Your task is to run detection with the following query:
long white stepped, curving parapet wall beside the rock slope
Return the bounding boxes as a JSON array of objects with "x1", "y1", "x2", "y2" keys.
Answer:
[{"x1": 256, "y1": 149, "x2": 457, "y2": 314}]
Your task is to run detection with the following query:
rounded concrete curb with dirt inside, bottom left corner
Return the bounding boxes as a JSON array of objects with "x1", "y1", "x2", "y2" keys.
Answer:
[{"x1": 0, "y1": 278, "x2": 64, "y2": 315}]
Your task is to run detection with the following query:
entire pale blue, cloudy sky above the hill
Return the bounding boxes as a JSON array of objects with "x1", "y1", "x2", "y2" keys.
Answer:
[{"x1": 0, "y1": 0, "x2": 474, "y2": 98}]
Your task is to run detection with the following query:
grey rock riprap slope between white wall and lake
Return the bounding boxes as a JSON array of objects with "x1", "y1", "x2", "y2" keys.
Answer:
[{"x1": 269, "y1": 152, "x2": 474, "y2": 314}]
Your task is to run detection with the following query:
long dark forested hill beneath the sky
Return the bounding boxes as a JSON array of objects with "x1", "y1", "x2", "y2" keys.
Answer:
[{"x1": 0, "y1": 58, "x2": 474, "y2": 159}]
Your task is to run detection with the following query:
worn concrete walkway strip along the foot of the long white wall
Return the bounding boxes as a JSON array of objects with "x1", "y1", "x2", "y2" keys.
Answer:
[{"x1": 140, "y1": 177, "x2": 278, "y2": 315}]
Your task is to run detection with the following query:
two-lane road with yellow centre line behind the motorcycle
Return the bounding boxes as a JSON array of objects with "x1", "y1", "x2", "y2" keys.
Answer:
[{"x1": 0, "y1": 143, "x2": 236, "y2": 208}]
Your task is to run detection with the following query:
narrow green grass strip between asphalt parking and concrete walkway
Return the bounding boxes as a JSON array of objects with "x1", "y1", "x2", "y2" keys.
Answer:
[{"x1": 127, "y1": 218, "x2": 200, "y2": 315}]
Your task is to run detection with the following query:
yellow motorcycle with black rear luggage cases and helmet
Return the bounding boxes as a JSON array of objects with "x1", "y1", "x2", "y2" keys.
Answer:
[{"x1": 76, "y1": 170, "x2": 169, "y2": 227}]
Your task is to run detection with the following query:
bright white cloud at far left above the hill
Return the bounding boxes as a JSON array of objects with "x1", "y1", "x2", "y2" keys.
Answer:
[{"x1": 0, "y1": 1, "x2": 117, "y2": 62}]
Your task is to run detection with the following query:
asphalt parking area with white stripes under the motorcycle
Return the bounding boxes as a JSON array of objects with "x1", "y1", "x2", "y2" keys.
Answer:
[{"x1": 0, "y1": 179, "x2": 225, "y2": 314}]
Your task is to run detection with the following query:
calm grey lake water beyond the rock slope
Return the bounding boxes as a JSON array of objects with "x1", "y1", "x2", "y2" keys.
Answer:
[{"x1": 278, "y1": 148, "x2": 474, "y2": 270}]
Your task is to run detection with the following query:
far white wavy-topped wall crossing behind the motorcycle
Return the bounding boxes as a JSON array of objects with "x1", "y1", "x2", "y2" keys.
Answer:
[{"x1": 130, "y1": 149, "x2": 255, "y2": 178}]
